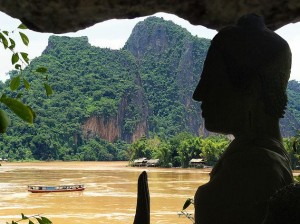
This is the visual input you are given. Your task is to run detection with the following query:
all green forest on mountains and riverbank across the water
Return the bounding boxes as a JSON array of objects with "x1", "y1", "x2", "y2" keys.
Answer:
[{"x1": 0, "y1": 17, "x2": 300, "y2": 167}]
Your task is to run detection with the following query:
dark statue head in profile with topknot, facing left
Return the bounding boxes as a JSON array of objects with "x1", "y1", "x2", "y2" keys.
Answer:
[{"x1": 193, "y1": 14, "x2": 291, "y2": 134}]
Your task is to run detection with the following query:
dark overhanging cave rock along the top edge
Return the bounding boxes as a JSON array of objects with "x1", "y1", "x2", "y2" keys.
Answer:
[{"x1": 0, "y1": 0, "x2": 300, "y2": 33}]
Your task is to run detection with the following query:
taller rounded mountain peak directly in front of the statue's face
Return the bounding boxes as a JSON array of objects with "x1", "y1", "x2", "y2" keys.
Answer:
[{"x1": 124, "y1": 17, "x2": 210, "y2": 137}]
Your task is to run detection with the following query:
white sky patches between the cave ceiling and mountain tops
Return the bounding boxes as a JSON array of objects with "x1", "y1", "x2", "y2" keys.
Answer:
[{"x1": 0, "y1": 12, "x2": 300, "y2": 81}]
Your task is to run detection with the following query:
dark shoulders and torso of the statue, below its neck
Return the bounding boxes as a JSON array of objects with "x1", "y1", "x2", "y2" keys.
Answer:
[{"x1": 195, "y1": 136, "x2": 293, "y2": 224}]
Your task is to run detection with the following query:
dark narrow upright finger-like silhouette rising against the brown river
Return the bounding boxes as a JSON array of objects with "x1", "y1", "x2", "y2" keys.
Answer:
[{"x1": 133, "y1": 171, "x2": 150, "y2": 224}]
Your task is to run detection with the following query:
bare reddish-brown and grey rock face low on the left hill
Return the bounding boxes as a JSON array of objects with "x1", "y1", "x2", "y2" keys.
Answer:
[{"x1": 82, "y1": 71, "x2": 148, "y2": 142}]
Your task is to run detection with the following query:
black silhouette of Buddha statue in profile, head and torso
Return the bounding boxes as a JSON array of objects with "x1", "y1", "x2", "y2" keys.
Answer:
[{"x1": 134, "y1": 14, "x2": 293, "y2": 224}]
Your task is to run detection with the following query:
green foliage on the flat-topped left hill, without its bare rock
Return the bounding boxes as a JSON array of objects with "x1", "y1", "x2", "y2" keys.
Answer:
[{"x1": 0, "y1": 36, "x2": 143, "y2": 160}]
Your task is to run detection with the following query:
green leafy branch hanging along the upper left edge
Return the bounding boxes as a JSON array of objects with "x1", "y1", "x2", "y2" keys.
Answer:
[{"x1": 0, "y1": 24, "x2": 53, "y2": 133}]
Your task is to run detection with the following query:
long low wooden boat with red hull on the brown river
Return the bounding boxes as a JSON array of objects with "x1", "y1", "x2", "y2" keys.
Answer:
[{"x1": 28, "y1": 184, "x2": 85, "y2": 193}]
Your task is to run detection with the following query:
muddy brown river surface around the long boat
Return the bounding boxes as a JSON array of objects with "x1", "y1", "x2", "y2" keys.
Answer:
[{"x1": 0, "y1": 162, "x2": 209, "y2": 224}]
